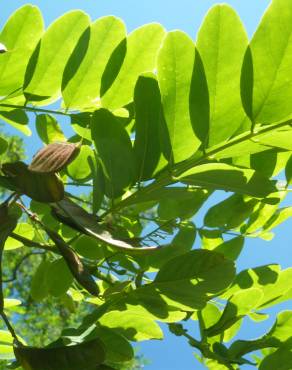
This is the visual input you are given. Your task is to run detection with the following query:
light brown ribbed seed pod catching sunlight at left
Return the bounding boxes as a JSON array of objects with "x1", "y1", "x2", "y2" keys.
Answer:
[{"x1": 28, "y1": 142, "x2": 80, "y2": 173}]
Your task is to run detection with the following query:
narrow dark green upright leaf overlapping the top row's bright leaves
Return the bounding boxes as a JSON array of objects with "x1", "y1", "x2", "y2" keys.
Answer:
[{"x1": 134, "y1": 74, "x2": 161, "y2": 182}]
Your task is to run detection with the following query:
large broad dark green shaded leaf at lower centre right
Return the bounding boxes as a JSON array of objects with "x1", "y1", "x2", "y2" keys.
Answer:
[{"x1": 143, "y1": 250, "x2": 235, "y2": 310}]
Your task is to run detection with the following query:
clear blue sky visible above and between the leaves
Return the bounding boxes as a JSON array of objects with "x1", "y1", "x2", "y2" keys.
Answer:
[{"x1": 0, "y1": 0, "x2": 292, "y2": 370}]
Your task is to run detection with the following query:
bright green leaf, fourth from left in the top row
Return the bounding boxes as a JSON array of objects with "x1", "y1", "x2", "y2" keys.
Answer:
[{"x1": 101, "y1": 23, "x2": 165, "y2": 110}]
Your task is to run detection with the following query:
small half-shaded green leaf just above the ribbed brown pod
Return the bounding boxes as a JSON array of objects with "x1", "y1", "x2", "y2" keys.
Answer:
[{"x1": 35, "y1": 114, "x2": 66, "y2": 144}]
